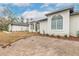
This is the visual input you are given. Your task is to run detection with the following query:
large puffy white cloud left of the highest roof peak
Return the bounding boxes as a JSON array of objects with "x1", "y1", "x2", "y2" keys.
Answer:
[{"x1": 22, "y1": 10, "x2": 48, "y2": 18}]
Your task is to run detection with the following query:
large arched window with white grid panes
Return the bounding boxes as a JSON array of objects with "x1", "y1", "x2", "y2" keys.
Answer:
[{"x1": 51, "y1": 15, "x2": 63, "y2": 29}]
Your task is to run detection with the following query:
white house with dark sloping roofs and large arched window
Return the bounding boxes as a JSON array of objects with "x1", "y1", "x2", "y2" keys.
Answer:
[{"x1": 8, "y1": 8, "x2": 79, "y2": 36}]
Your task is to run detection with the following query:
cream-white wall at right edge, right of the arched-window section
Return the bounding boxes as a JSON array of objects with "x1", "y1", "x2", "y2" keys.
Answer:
[{"x1": 70, "y1": 15, "x2": 79, "y2": 36}]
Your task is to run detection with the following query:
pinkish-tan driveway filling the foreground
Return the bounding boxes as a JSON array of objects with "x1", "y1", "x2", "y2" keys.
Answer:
[{"x1": 0, "y1": 36, "x2": 79, "y2": 56}]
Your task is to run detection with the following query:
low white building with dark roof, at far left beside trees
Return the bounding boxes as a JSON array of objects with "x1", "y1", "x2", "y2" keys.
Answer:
[{"x1": 9, "y1": 23, "x2": 29, "y2": 32}]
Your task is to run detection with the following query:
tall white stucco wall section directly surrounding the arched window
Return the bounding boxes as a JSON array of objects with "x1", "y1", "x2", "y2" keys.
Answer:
[{"x1": 48, "y1": 10, "x2": 70, "y2": 36}]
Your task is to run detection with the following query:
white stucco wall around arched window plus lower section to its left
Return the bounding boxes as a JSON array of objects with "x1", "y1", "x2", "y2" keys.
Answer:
[{"x1": 40, "y1": 10, "x2": 70, "y2": 36}]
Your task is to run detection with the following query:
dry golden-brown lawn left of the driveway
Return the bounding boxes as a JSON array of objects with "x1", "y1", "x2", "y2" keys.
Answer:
[{"x1": 0, "y1": 32, "x2": 37, "y2": 47}]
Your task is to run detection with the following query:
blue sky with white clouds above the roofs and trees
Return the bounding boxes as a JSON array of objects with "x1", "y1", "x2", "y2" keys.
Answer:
[{"x1": 0, "y1": 3, "x2": 79, "y2": 18}]
